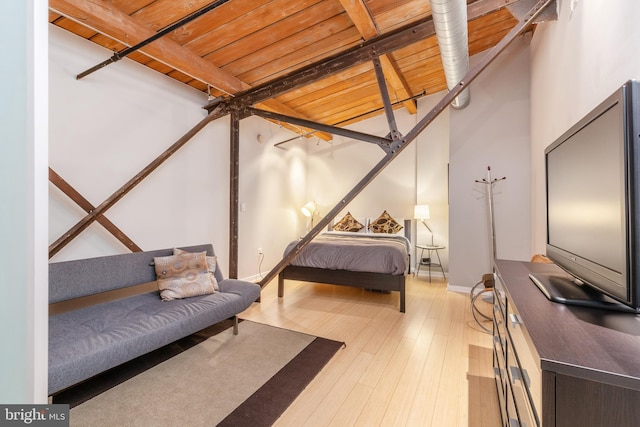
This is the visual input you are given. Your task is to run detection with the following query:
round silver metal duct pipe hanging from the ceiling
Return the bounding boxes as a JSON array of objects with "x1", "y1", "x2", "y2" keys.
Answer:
[{"x1": 429, "y1": 0, "x2": 471, "y2": 109}]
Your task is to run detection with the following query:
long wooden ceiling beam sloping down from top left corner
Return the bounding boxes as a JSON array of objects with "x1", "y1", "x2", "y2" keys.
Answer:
[{"x1": 49, "y1": 0, "x2": 332, "y2": 141}]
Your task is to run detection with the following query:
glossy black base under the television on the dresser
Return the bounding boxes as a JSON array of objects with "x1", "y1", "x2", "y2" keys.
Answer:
[{"x1": 529, "y1": 272, "x2": 639, "y2": 314}]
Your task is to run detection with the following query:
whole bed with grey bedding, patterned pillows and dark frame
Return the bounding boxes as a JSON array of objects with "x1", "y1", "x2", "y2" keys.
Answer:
[{"x1": 278, "y1": 211, "x2": 411, "y2": 313}]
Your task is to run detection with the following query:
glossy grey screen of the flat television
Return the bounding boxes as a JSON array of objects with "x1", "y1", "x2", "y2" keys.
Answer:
[{"x1": 547, "y1": 103, "x2": 626, "y2": 297}]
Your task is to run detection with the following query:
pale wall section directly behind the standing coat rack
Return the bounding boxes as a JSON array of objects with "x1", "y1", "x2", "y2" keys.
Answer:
[{"x1": 449, "y1": 37, "x2": 531, "y2": 288}]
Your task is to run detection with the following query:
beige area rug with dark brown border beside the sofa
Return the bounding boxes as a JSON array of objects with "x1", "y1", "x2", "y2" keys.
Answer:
[{"x1": 54, "y1": 321, "x2": 343, "y2": 427}]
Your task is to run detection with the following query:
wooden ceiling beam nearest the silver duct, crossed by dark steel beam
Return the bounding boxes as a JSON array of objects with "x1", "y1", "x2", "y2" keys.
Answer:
[{"x1": 340, "y1": 0, "x2": 418, "y2": 114}]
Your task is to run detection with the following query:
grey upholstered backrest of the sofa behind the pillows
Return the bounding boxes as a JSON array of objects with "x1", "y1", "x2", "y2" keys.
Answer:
[{"x1": 49, "y1": 244, "x2": 218, "y2": 304}]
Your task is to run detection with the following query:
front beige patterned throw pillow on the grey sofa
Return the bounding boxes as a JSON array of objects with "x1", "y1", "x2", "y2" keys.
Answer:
[{"x1": 153, "y1": 252, "x2": 215, "y2": 301}]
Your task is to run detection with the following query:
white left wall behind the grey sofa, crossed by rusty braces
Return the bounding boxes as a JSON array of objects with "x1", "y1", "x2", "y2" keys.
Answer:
[{"x1": 49, "y1": 26, "x2": 303, "y2": 277}]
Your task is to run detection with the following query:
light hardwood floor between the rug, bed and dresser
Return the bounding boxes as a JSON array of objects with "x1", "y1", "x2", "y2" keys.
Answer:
[{"x1": 240, "y1": 277, "x2": 500, "y2": 427}]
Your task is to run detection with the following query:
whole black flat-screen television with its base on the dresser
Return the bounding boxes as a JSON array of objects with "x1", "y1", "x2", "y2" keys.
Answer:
[{"x1": 531, "y1": 80, "x2": 640, "y2": 313}]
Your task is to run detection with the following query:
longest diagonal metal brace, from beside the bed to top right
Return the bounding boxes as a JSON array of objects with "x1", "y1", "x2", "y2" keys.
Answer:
[{"x1": 259, "y1": 0, "x2": 556, "y2": 287}]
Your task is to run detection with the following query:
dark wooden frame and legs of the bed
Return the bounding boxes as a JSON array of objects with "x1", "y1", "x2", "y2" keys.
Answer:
[{"x1": 278, "y1": 220, "x2": 411, "y2": 313}]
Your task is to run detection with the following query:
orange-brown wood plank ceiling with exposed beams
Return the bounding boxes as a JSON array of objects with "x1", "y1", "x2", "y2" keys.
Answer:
[{"x1": 49, "y1": 0, "x2": 518, "y2": 139}]
